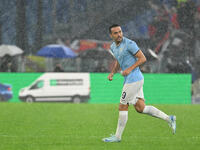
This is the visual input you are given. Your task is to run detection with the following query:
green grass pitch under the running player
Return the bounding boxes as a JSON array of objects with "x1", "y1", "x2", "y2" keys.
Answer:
[{"x1": 0, "y1": 103, "x2": 200, "y2": 150}]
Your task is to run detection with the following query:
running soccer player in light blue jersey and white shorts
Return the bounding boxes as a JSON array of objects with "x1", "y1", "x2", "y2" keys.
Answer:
[{"x1": 102, "y1": 24, "x2": 176, "y2": 142}]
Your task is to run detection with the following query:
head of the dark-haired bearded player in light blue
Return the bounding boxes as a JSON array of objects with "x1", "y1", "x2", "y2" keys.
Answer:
[{"x1": 110, "y1": 27, "x2": 123, "y2": 43}]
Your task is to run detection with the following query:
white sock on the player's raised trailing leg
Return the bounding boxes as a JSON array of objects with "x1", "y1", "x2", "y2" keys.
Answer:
[{"x1": 143, "y1": 106, "x2": 169, "y2": 122}]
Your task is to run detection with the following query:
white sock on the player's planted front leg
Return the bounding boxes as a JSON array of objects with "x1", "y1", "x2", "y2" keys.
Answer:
[{"x1": 115, "y1": 111, "x2": 128, "y2": 139}]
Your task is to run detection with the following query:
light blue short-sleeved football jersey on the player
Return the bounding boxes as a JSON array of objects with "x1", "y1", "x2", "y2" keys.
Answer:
[{"x1": 110, "y1": 37, "x2": 144, "y2": 84}]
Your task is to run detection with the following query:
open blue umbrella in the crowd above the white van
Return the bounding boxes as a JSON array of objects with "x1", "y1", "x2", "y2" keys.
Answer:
[{"x1": 36, "y1": 44, "x2": 76, "y2": 58}]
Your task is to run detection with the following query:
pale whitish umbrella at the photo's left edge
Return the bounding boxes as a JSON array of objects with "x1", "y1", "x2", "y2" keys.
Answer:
[{"x1": 0, "y1": 45, "x2": 23, "y2": 57}]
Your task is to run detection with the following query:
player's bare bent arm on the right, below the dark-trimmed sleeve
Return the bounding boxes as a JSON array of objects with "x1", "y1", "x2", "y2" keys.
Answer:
[{"x1": 122, "y1": 50, "x2": 146, "y2": 76}]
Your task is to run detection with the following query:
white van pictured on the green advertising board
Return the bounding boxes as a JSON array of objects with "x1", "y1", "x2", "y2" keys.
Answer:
[{"x1": 19, "y1": 73, "x2": 90, "y2": 103}]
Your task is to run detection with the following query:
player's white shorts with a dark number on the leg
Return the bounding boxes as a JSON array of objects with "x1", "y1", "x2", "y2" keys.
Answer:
[{"x1": 120, "y1": 80, "x2": 144, "y2": 105}]
